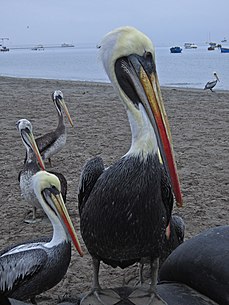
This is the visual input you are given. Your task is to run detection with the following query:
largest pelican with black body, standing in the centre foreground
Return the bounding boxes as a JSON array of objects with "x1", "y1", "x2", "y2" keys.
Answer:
[{"x1": 79, "y1": 27, "x2": 182, "y2": 303}]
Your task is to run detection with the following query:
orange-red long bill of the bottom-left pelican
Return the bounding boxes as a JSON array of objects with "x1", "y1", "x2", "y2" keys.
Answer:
[{"x1": 51, "y1": 193, "x2": 83, "y2": 256}]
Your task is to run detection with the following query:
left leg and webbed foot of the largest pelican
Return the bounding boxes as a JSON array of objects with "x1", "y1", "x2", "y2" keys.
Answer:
[{"x1": 80, "y1": 258, "x2": 120, "y2": 305}]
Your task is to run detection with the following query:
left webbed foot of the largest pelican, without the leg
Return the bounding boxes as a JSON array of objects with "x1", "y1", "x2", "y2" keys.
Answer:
[{"x1": 80, "y1": 289, "x2": 121, "y2": 305}]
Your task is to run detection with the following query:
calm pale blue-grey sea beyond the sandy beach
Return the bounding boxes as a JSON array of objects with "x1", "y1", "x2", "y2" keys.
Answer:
[{"x1": 0, "y1": 45, "x2": 229, "y2": 90}]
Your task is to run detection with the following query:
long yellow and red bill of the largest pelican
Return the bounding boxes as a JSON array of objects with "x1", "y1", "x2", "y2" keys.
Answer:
[{"x1": 127, "y1": 55, "x2": 183, "y2": 207}]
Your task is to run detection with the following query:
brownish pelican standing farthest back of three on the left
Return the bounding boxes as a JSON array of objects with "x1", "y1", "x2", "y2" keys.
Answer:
[{"x1": 36, "y1": 90, "x2": 74, "y2": 164}]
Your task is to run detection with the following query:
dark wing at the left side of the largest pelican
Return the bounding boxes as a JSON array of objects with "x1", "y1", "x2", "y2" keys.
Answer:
[{"x1": 78, "y1": 157, "x2": 104, "y2": 213}]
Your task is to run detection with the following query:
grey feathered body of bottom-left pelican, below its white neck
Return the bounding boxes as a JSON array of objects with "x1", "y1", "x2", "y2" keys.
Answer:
[{"x1": 0, "y1": 239, "x2": 71, "y2": 300}]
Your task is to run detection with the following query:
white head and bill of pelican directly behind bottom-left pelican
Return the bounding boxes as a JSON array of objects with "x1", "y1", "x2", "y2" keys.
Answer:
[{"x1": 16, "y1": 119, "x2": 45, "y2": 170}]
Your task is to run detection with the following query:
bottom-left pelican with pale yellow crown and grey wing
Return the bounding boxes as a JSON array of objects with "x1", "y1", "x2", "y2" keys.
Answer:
[{"x1": 0, "y1": 171, "x2": 83, "y2": 302}]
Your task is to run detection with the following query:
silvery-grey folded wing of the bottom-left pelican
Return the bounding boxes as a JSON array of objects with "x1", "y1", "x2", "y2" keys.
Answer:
[{"x1": 0, "y1": 249, "x2": 47, "y2": 292}]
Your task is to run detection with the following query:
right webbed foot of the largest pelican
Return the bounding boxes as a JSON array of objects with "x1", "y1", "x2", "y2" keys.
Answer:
[{"x1": 128, "y1": 285, "x2": 168, "y2": 305}]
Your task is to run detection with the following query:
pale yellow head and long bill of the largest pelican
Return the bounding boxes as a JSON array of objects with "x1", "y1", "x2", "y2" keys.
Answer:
[{"x1": 99, "y1": 27, "x2": 182, "y2": 206}]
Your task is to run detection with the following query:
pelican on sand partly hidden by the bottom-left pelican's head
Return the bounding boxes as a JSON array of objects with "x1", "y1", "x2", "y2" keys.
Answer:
[{"x1": 16, "y1": 119, "x2": 67, "y2": 223}]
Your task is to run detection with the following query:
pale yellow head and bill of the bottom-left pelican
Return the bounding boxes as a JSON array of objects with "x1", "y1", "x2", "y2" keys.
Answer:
[{"x1": 32, "y1": 171, "x2": 83, "y2": 256}]
